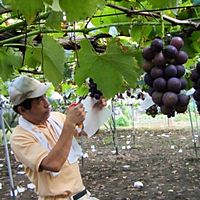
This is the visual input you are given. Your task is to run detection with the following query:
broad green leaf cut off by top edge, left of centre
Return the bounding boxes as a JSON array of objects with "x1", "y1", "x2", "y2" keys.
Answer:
[{"x1": 60, "y1": 0, "x2": 105, "y2": 22}]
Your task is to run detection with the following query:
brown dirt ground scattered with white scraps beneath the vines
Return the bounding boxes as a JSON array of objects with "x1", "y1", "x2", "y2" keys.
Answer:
[{"x1": 0, "y1": 128, "x2": 200, "y2": 200}]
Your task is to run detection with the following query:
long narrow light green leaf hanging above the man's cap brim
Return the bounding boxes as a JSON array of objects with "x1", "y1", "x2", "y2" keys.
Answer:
[{"x1": 42, "y1": 35, "x2": 66, "y2": 87}]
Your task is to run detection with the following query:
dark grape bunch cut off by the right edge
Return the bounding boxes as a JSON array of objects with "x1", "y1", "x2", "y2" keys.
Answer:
[{"x1": 190, "y1": 62, "x2": 200, "y2": 114}]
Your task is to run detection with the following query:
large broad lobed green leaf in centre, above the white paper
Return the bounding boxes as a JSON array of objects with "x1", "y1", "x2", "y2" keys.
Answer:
[{"x1": 75, "y1": 39, "x2": 142, "y2": 98}]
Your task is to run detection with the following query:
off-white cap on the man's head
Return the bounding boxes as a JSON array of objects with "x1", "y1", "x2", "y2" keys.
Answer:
[{"x1": 8, "y1": 76, "x2": 51, "y2": 105}]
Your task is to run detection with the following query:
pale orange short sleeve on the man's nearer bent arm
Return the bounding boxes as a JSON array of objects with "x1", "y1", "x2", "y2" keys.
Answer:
[{"x1": 10, "y1": 130, "x2": 49, "y2": 171}]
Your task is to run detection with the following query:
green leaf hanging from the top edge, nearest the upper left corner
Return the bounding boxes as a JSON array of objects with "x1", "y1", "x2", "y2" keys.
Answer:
[{"x1": 12, "y1": 0, "x2": 43, "y2": 24}]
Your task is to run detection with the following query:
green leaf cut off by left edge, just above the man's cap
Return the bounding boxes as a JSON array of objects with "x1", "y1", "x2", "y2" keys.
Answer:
[{"x1": 0, "y1": 48, "x2": 22, "y2": 81}]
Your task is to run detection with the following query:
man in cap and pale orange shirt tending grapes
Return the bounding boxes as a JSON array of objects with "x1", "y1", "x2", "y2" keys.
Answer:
[{"x1": 9, "y1": 76, "x2": 105, "y2": 200}]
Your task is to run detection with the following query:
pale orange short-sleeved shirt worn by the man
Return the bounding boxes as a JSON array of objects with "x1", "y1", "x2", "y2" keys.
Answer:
[{"x1": 10, "y1": 112, "x2": 84, "y2": 200}]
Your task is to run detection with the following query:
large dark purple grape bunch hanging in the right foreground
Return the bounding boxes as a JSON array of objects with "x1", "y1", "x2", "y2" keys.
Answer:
[{"x1": 143, "y1": 36, "x2": 189, "y2": 117}]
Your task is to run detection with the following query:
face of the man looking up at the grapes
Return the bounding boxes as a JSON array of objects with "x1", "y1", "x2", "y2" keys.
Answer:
[{"x1": 21, "y1": 95, "x2": 51, "y2": 124}]
